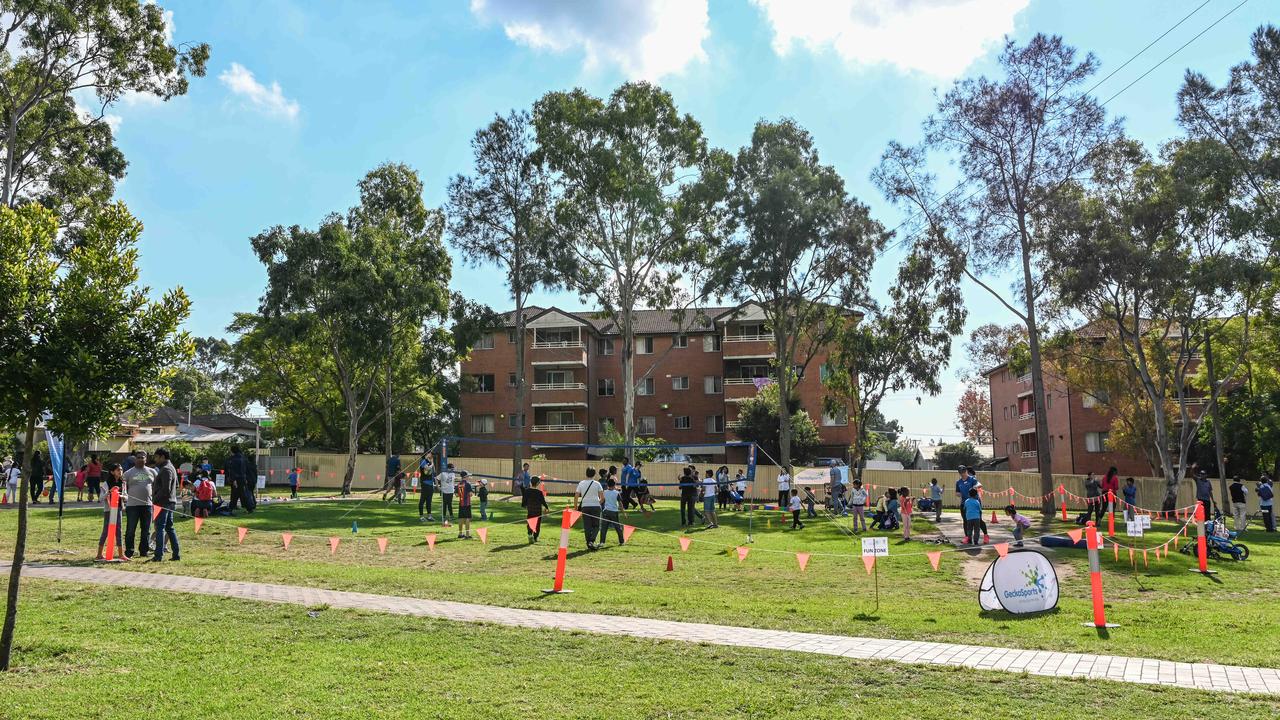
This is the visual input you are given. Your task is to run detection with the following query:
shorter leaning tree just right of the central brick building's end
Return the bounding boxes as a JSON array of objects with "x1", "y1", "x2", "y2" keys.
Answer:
[{"x1": 823, "y1": 245, "x2": 965, "y2": 478}]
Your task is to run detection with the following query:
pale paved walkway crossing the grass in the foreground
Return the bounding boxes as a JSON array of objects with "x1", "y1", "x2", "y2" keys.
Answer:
[{"x1": 12, "y1": 565, "x2": 1280, "y2": 694}]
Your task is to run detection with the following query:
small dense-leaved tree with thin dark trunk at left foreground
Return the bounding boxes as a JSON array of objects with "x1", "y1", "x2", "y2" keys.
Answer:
[{"x1": 0, "y1": 204, "x2": 189, "y2": 670}]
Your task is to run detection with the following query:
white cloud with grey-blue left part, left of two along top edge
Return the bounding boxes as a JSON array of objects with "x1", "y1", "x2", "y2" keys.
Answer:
[{"x1": 471, "y1": 0, "x2": 710, "y2": 79}]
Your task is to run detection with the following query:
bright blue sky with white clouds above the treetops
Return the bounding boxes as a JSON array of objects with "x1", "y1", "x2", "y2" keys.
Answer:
[{"x1": 111, "y1": 0, "x2": 1276, "y2": 439}]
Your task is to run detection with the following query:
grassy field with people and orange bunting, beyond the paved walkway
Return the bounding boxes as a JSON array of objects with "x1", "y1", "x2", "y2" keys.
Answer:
[{"x1": 0, "y1": 491, "x2": 1280, "y2": 667}]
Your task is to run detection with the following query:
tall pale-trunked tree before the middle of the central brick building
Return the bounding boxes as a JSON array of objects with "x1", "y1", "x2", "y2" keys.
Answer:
[{"x1": 534, "y1": 82, "x2": 731, "y2": 456}]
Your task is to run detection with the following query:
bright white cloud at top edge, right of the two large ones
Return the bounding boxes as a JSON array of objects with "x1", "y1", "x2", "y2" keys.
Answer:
[{"x1": 751, "y1": 0, "x2": 1030, "y2": 77}]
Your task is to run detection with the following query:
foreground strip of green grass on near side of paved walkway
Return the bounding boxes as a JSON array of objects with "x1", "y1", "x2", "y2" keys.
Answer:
[{"x1": 0, "y1": 580, "x2": 1280, "y2": 720}]
